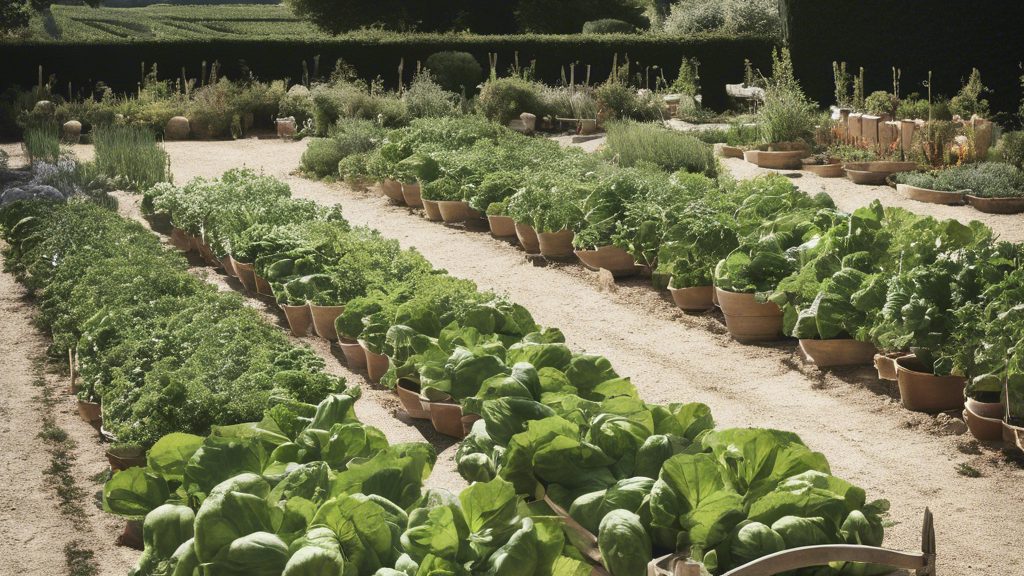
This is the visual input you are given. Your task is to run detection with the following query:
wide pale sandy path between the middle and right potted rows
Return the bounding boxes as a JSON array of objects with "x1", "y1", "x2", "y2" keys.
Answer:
[{"x1": 2, "y1": 139, "x2": 1024, "y2": 576}]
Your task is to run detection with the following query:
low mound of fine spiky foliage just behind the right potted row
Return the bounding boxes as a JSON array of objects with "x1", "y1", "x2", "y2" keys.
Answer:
[{"x1": 604, "y1": 122, "x2": 718, "y2": 177}]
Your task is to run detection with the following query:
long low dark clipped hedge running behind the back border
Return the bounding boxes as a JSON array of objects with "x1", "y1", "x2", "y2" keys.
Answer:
[{"x1": 0, "y1": 34, "x2": 775, "y2": 109}]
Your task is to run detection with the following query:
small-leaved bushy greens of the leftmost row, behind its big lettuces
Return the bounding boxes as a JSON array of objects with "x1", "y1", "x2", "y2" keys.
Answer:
[{"x1": 0, "y1": 195, "x2": 352, "y2": 447}]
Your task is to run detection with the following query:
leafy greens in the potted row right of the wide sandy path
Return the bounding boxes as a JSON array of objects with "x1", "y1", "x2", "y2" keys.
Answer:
[{"x1": 323, "y1": 114, "x2": 1024, "y2": 412}]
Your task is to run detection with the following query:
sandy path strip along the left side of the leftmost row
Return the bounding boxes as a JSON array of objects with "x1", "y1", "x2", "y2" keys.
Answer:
[{"x1": 0, "y1": 249, "x2": 138, "y2": 576}]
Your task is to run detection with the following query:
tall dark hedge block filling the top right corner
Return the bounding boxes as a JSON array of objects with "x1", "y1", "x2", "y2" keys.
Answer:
[{"x1": 783, "y1": 0, "x2": 1024, "y2": 118}]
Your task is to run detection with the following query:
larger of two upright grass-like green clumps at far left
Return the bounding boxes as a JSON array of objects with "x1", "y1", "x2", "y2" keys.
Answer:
[{"x1": 92, "y1": 126, "x2": 172, "y2": 192}]
